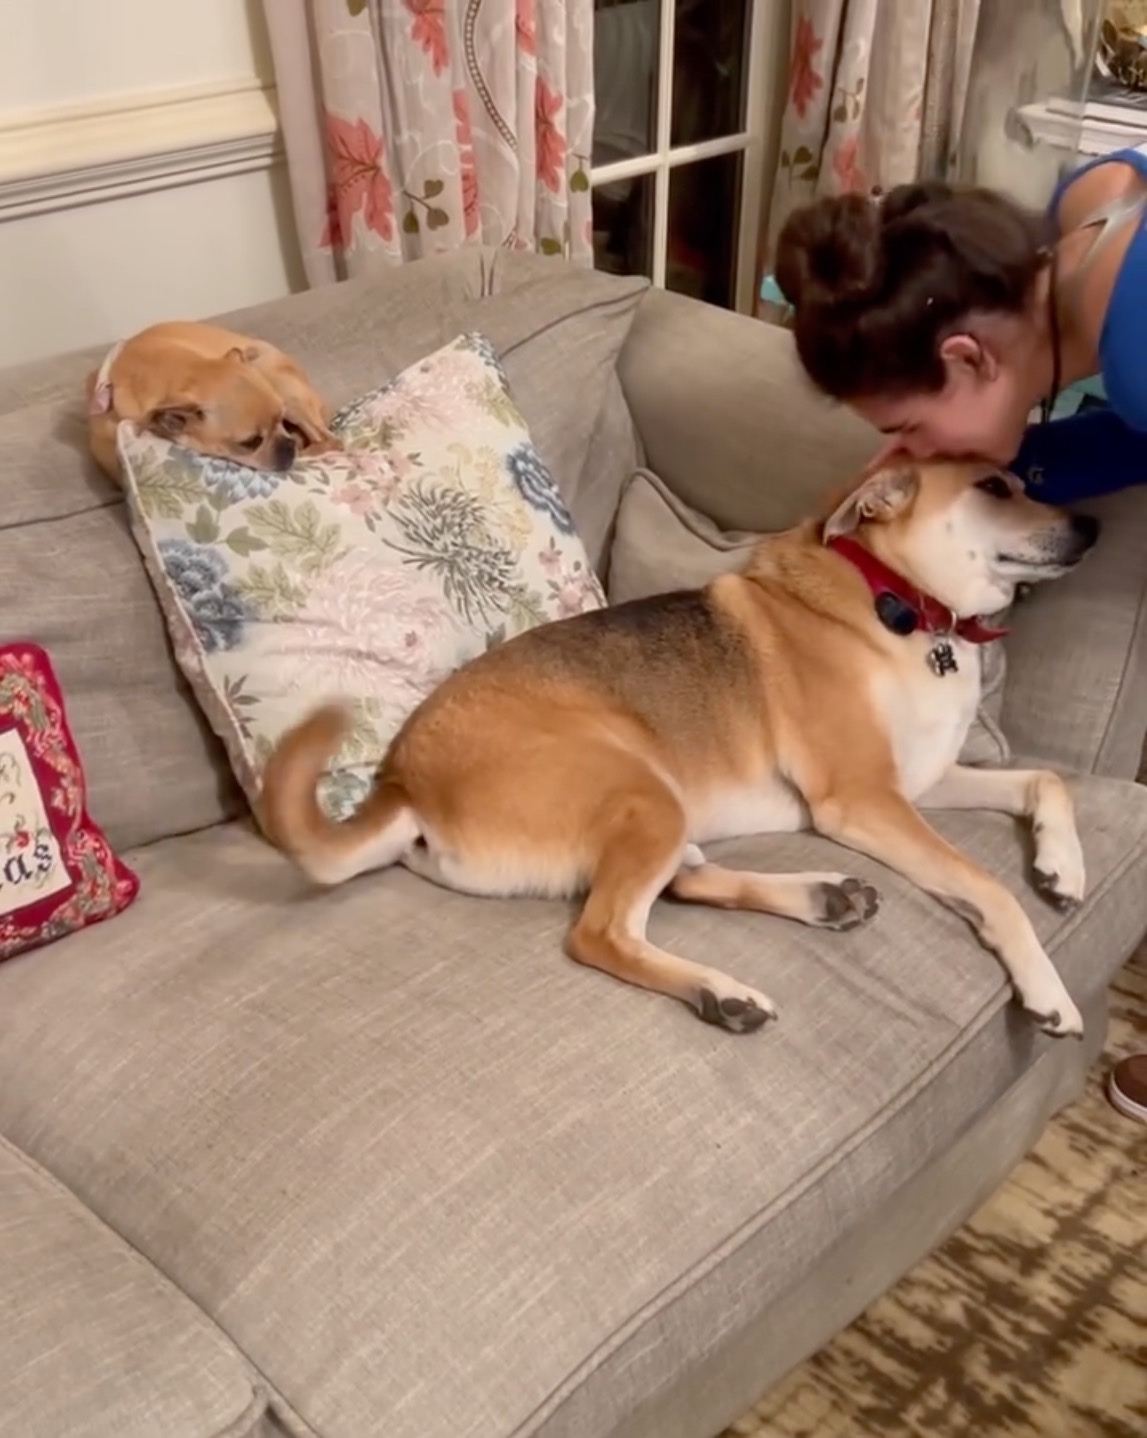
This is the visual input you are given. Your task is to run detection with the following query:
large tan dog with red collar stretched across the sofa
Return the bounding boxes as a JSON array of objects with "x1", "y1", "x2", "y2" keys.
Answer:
[{"x1": 262, "y1": 463, "x2": 1098, "y2": 1035}]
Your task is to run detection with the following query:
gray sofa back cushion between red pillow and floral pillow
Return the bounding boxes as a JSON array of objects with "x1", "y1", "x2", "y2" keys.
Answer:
[{"x1": 0, "y1": 400, "x2": 243, "y2": 846}]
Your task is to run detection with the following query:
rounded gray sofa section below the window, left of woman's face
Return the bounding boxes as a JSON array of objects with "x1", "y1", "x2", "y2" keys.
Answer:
[{"x1": 618, "y1": 289, "x2": 880, "y2": 531}]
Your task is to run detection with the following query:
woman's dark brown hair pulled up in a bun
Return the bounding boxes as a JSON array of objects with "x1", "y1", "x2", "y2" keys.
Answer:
[{"x1": 776, "y1": 183, "x2": 1051, "y2": 400}]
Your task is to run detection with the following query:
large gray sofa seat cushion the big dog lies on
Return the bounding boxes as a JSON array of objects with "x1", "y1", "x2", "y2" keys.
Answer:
[{"x1": 0, "y1": 779, "x2": 1147, "y2": 1438}]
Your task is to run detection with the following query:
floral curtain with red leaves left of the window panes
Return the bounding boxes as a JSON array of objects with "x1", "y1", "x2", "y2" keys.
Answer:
[{"x1": 263, "y1": 0, "x2": 594, "y2": 285}]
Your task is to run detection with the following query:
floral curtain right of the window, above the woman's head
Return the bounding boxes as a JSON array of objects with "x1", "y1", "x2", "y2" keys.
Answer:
[{"x1": 766, "y1": 0, "x2": 980, "y2": 256}]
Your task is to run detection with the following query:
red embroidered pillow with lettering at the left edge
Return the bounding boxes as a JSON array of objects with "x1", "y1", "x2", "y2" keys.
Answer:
[{"x1": 0, "y1": 644, "x2": 139, "y2": 959}]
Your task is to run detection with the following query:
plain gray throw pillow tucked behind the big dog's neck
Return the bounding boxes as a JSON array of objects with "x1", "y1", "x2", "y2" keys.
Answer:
[{"x1": 609, "y1": 469, "x2": 1010, "y2": 765}]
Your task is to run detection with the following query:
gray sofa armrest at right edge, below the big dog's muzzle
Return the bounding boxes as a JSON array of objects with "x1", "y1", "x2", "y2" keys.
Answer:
[{"x1": 1002, "y1": 487, "x2": 1147, "y2": 779}]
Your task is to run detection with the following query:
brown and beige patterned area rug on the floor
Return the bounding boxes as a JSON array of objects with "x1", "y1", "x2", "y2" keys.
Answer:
[{"x1": 722, "y1": 945, "x2": 1147, "y2": 1438}]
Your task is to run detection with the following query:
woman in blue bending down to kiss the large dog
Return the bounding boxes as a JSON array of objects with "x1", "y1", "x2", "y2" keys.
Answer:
[{"x1": 776, "y1": 147, "x2": 1147, "y2": 1122}]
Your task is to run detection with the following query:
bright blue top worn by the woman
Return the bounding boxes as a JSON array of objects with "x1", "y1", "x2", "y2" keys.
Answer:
[{"x1": 1013, "y1": 145, "x2": 1147, "y2": 505}]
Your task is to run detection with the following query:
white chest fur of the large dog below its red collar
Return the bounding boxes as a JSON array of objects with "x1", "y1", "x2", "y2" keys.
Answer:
[{"x1": 874, "y1": 634, "x2": 980, "y2": 800}]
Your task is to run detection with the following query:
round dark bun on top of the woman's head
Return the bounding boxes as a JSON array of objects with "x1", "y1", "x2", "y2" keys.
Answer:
[{"x1": 776, "y1": 194, "x2": 884, "y2": 306}]
